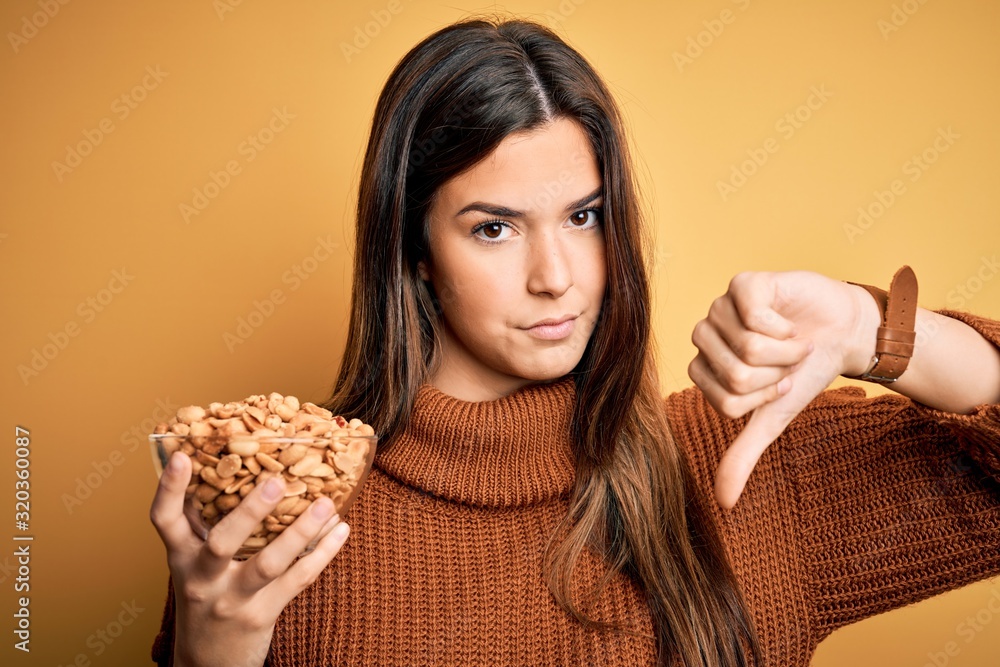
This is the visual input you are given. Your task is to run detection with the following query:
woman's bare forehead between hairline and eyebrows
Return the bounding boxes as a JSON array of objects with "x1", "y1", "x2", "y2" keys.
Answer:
[{"x1": 436, "y1": 118, "x2": 601, "y2": 215}]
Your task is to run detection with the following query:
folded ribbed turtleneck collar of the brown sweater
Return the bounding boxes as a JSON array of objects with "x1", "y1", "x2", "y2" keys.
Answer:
[{"x1": 375, "y1": 377, "x2": 576, "y2": 508}]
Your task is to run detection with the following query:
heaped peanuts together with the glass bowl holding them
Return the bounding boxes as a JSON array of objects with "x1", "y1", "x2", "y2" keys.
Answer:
[{"x1": 149, "y1": 393, "x2": 378, "y2": 559}]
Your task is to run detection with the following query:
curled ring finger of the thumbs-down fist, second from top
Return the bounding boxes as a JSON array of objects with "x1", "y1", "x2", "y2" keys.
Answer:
[{"x1": 707, "y1": 298, "x2": 812, "y2": 370}]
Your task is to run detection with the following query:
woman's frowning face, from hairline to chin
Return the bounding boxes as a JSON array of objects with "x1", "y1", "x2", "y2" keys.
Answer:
[{"x1": 420, "y1": 119, "x2": 607, "y2": 401}]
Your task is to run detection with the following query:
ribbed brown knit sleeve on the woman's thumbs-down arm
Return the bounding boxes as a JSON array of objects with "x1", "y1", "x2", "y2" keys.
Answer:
[{"x1": 781, "y1": 311, "x2": 1000, "y2": 639}]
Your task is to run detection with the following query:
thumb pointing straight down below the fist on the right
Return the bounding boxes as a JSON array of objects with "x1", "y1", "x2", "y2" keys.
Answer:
[{"x1": 715, "y1": 388, "x2": 803, "y2": 509}]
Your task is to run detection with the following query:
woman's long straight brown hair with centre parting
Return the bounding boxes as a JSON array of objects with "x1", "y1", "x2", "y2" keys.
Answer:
[{"x1": 326, "y1": 20, "x2": 761, "y2": 667}]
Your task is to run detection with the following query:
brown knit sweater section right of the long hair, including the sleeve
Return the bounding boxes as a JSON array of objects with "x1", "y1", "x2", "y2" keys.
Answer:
[{"x1": 665, "y1": 311, "x2": 1000, "y2": 664}]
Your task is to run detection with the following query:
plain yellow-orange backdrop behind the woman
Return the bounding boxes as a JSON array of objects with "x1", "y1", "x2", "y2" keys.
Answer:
[{"x1": 0, "y1": 0, "x2": 1000, "y2": 667}]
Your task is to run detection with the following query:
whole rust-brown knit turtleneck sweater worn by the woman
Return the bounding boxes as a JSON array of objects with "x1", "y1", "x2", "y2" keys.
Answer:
[{"x1": 153, "y1": 313, "x2": 1000, "y2": 667}]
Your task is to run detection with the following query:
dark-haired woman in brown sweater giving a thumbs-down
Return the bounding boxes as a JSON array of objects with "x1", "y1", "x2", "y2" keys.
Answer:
[{"x1": 151, "y1": 15, "x2": 1000, "y2": 667}]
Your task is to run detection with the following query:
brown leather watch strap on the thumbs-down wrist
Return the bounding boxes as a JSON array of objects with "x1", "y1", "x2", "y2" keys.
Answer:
[{"x1": 850, "y1": 266, "x2": 917, "y2": 384}]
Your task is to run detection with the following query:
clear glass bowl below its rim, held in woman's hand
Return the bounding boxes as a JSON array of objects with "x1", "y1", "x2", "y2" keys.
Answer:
[{"x1": 149, "y1": 433, "x2": 378, "y2": 560}]
